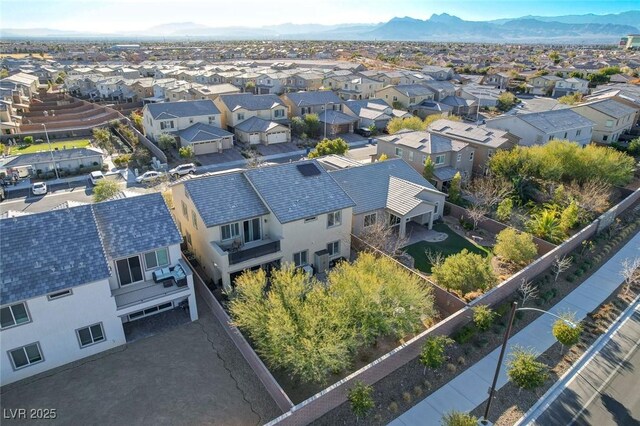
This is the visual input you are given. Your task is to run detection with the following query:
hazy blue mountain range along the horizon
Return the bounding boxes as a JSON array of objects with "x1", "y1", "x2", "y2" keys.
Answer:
[{"x1": 0, "y1": 10, "x2": 640, "y2": 44}]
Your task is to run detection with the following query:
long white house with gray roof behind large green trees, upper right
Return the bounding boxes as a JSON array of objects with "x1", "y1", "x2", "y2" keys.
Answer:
[{"x1": 486, "y1": 108, "x2": 594, "y2": 146}]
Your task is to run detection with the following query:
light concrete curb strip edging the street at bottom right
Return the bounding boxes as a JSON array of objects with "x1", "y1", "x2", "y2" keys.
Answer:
[{"x1": 514, "y1": 295, "x2": 640, "y2": 426}]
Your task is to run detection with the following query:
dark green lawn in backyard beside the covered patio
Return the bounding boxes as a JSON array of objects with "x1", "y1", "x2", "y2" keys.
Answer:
[{"x1": 405, "y1": 223, "x2": 491, "y2": 274}]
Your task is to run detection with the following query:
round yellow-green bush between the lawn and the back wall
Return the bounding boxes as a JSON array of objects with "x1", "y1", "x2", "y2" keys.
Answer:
[{"x1": 431, "y1": 249, "x2": 497, "y2": 295}]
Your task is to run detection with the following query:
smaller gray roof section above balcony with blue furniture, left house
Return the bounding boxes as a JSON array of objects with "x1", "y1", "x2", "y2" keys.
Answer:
[{"x1": 93, "y1": 193, "x2": 182, "y2": 259}]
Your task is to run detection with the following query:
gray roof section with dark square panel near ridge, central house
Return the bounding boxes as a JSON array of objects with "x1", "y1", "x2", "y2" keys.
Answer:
[{"x1": 245, "y1": 160, "x2": 355, "y2": 223}]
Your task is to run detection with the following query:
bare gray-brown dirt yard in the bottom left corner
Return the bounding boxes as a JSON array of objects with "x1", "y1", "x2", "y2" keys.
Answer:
[{"x1": 0, "y1": 305, "x2": 281, "y2": 425}]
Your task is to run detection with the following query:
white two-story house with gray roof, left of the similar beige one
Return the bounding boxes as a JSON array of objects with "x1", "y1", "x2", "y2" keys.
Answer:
[{"x1": 142, "y1": 99, "x2": 222, "y2": 146}]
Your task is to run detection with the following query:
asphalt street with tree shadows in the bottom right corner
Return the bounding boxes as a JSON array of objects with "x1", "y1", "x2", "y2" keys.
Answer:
[{"x1": 535, "y1": 310, "x2": 640, "y2": 426}]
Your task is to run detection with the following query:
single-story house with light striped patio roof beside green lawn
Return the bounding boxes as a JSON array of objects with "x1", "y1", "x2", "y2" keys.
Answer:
[{"x1": 320, "y1": 158, "x2": 445, "y2": 238}]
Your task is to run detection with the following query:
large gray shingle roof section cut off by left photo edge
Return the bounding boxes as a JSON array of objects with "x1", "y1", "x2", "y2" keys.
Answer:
[{"x1": 0, "y1": 206, "x2": 109, "y2": 305}]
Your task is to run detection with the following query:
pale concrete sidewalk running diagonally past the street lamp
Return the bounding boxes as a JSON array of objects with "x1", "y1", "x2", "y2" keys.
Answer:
[{"x1": 390, "y1": 233, "x2": 640, "y2": 426}]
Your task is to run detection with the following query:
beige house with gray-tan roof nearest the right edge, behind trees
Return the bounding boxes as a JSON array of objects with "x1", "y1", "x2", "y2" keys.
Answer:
[{"x1": 571, "y1": 99, "x2": 638, "y2": 144}]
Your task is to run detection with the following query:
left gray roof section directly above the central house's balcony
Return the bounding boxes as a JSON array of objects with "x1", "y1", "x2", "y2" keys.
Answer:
[{"x1": 184, "y1": 172, "x2": 269, "y2": 227}]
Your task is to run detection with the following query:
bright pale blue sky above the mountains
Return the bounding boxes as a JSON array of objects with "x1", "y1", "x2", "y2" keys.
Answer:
[{"x1": 0, "y1": 0, "x2": 640, "y2": 33}]
